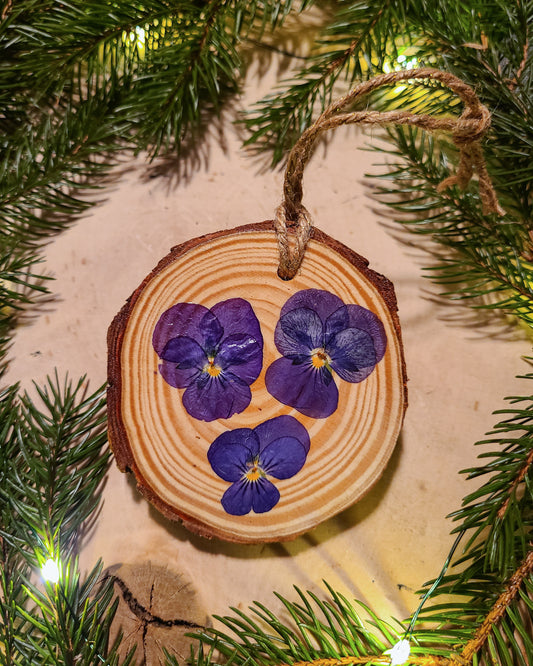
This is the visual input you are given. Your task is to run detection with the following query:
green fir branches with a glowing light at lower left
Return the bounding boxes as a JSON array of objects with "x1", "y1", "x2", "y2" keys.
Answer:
[{"x1": 0, "y1": 377, "x2": 131, "y2": 666}]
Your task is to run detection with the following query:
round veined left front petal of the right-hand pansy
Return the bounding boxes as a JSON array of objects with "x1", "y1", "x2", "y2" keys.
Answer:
[{"x1": 274, "y1": 308, "x2": 324, "y2": 356}]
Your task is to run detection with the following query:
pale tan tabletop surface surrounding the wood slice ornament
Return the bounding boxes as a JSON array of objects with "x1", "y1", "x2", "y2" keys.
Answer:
[{"x1": 5, "y1": 50, "x2": 529, "y2": 648}]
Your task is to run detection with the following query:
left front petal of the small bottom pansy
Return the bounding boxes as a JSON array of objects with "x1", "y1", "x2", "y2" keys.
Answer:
[{"x1": 207, "y1": 428, "x2": 259, "y2": 481}]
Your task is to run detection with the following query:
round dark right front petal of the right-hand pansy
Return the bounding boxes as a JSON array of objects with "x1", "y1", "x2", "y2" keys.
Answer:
[{"x1": 327, "y1": 328, "x2": 376, "y2": 382}]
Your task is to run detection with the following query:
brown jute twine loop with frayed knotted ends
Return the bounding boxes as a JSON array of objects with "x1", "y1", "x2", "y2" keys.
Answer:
[{"x1": 274, "y1": 67, "x2": 505, "y2": 280}]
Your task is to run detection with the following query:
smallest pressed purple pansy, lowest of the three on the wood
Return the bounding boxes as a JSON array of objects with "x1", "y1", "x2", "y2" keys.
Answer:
[{"x1": 207, "y1": 415, "x2": 310, "y2": 516}]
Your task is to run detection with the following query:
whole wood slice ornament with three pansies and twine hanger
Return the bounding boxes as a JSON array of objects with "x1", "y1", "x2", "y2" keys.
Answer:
[{"x1": 108, "y1": 69, "x2": 497, "y2": 543}]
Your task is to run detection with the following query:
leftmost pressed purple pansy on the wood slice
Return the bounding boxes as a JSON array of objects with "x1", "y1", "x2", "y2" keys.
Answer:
[{"x1": 152, "y1": 298, "x2": 263, "y2": 421}]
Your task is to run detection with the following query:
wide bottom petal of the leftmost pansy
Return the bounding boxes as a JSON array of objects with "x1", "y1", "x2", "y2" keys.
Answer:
[{"x1": 182, "y1": 372, "x2": 252, "y2": 421}]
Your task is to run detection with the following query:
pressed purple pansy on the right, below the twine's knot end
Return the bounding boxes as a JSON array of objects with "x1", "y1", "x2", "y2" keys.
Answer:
[{"x1": 265, "y1": 289, "x2": 387, "y2": 419}]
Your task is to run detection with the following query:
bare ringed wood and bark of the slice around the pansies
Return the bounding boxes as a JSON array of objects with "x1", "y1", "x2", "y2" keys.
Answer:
[{"x1": 108, "y1": 222, "x2": 407, "y2": 543}]
